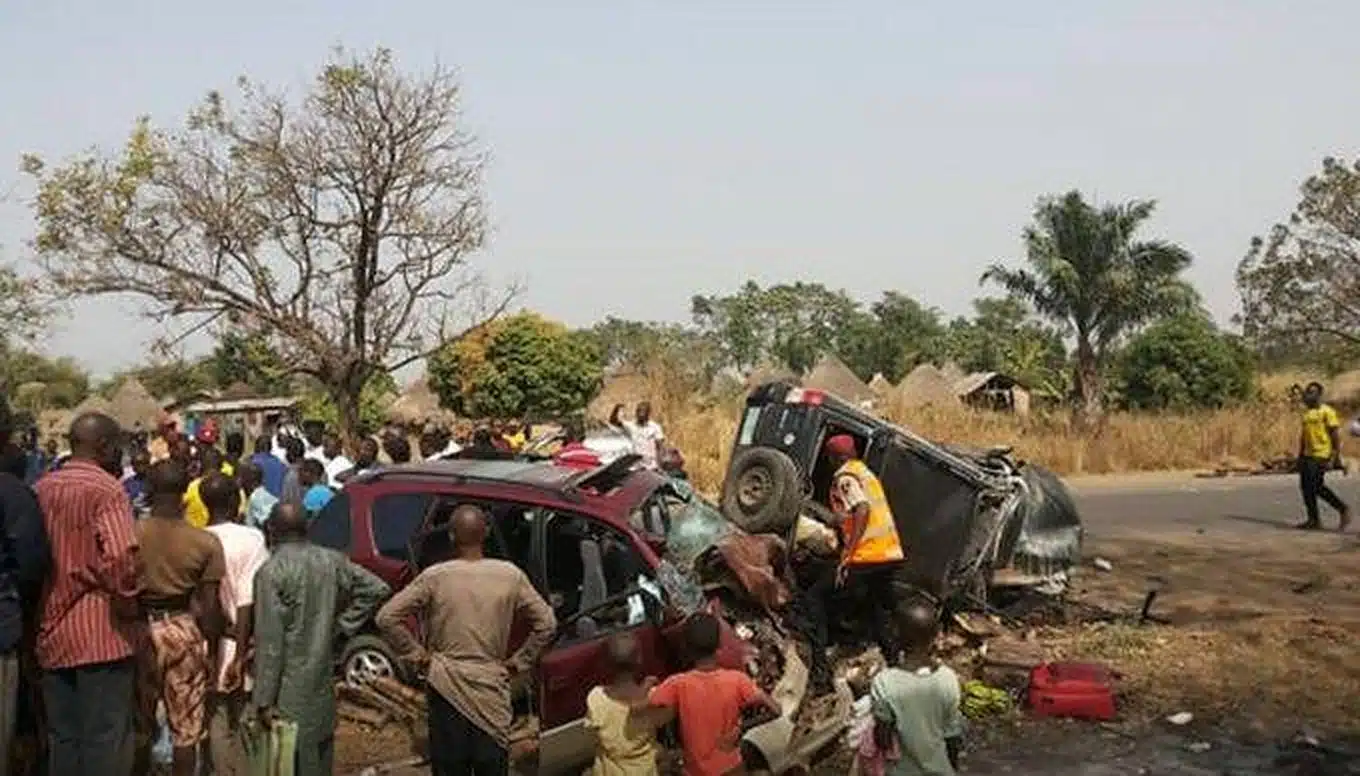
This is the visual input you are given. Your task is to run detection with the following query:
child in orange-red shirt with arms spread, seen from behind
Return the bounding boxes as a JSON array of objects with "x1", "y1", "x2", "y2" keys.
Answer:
[{"x1": 649, "y1": 613, "x2": 781, "y2": 776}]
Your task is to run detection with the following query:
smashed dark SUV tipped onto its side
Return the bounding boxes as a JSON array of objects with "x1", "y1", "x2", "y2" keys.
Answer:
[{"x1": 722, "y1": 382, "x2": 1081, "y2": 603}]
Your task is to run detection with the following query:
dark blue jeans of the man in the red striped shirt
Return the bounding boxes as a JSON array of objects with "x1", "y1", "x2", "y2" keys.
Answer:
[{"x1": 42, "y1": 659, "x2": 136, "y2": 776}]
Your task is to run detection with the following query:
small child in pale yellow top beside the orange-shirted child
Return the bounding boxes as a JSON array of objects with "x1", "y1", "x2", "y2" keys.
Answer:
[{"x1": 586, "y1": 633, "x2": 669, "y2": 776}]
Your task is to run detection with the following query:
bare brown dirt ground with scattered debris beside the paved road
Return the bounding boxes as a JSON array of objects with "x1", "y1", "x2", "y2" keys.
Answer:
[{"x1": 337, "y1": 533, "x2": 1360, "y2": 776}]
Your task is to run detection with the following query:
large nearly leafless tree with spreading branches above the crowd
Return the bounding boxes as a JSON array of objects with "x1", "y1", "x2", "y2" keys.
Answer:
[{"x1": 23, "y1": 49, "x2": 517, "y2": 434}]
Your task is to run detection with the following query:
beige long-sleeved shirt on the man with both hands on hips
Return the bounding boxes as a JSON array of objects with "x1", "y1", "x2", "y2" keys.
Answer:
[{"x1": 377, "y1": 559, "x2": 558, "y2": 746}]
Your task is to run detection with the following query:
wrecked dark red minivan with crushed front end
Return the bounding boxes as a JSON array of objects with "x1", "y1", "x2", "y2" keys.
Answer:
[{"x1": 310, "y1": 457, "x2": 748, "y2": 776}]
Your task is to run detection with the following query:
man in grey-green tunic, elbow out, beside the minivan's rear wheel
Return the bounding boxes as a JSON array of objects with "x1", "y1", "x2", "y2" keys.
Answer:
[{"x1": 248, "y1": 501, "x2": 390, "y2": 776}]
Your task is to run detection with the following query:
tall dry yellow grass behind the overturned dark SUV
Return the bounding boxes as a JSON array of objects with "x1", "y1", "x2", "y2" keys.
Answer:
[{"x1": 652, "y1": 375, "x2": 1299, "y2": 493}]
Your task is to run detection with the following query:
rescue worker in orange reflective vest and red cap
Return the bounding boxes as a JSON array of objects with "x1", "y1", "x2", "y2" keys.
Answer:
[{"x1": 824, "y1": 435, "x2": 911, "y2": 666}]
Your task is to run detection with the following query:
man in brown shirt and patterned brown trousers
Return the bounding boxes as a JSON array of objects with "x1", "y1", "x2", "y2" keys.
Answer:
[{"x1": 136, "y1": 458, "x2": 226, "y2": 776}]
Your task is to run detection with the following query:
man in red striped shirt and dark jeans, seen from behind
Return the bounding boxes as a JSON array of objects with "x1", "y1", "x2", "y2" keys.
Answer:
[{"x1": 34, "y1": 412, "x2": 137, "y2": 776}]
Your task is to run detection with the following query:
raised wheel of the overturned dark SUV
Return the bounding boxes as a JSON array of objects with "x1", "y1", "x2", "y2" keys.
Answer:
[{"x1": 722, "y1": 447, "x2": 802, "y2": 534}]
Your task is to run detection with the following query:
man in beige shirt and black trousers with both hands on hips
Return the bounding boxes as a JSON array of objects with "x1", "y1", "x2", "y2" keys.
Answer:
[{"x1": 378, "y1": 504, "x2": 558, "y2": 776}]
